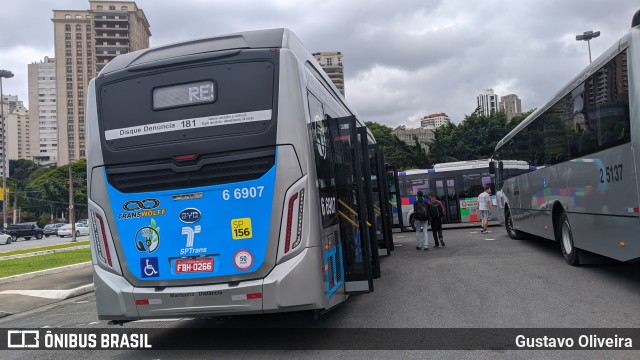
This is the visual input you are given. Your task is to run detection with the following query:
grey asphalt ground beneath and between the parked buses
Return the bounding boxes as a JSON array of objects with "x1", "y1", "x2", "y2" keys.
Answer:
[{"x1": 0, "y1": 227, "x2": 640, "y2": 359}]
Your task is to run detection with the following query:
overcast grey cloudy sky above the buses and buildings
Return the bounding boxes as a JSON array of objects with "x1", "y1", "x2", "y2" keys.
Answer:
[{"x1": 0, "y1": 0, "x2": 640, "y2": 126}]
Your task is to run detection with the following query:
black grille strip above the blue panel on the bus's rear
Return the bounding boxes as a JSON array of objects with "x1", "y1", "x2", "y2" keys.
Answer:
[{"x1": 107, "y1": 155, "x2": 275, "y2": 193}]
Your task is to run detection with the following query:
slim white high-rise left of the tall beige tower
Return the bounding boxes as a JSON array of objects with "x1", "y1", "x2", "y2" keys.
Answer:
[{"x1": 28, "y1": 56, "x2": 58, "y2": 166}]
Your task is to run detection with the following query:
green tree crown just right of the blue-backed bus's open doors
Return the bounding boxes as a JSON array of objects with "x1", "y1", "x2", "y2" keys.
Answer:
[{"x1": 366, "y1": 121, "x2": 428, "y2": 170}]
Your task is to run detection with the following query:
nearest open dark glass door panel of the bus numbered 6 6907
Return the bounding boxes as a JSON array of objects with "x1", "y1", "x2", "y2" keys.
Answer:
[{"x1": 327, "y1": 116, "x2": 373, "y2": 294}]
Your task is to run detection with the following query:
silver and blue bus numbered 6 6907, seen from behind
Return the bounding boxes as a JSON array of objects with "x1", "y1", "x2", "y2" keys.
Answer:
[{"x1": 87, "y1": 29, "x2": 392, "y2": 324}]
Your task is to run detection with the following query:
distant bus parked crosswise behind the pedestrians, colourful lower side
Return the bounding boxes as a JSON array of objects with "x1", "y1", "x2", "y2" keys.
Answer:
[{"x1": 398, "y1": 160, "x2": 496, "y2": 230}]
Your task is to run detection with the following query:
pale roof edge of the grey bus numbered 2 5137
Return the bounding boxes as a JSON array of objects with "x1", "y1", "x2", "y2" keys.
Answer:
[{"x1": 495, "y1": 27, "x2": 640, "y2": 150}]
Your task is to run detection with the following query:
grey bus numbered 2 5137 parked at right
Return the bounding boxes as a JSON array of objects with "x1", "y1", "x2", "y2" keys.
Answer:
[{"x1": 492, "y1": 15, "x2": 640, "y2": 265}]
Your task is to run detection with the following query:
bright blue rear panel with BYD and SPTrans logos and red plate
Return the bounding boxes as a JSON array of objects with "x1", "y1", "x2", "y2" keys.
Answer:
[{"x1": 107, "y1": 159, "x2": 277, "y2": 281}]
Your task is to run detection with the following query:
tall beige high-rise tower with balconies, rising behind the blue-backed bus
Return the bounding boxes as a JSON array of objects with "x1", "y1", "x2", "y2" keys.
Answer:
[{"x1": 51, "y1": 0, "x2": 151, "y2": 165}]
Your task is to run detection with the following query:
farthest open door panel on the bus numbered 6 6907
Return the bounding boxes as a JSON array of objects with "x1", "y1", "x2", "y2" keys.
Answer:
[{"x1": 369, "y1": 144, "x2": 393, "y2": 256}]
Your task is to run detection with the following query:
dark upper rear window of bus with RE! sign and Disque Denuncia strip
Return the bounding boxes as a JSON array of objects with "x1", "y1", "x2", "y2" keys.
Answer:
[{"x1": 99, "y1": 61, "x2": 275, "y2": 149}]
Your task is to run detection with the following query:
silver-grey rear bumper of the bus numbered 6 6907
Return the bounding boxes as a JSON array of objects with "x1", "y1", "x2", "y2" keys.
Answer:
[{"x1": 94, "y1": 247, "x2": 324, "y2": 322}]
